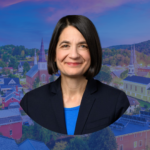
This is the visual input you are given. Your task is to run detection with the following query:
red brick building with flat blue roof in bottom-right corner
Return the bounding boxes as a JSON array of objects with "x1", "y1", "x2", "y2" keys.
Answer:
[{"x1": 110, "y1": 112, "x2": 150, "y2": 150}]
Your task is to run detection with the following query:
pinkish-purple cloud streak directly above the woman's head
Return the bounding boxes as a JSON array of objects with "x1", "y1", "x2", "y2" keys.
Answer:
[{"x1": 47, "y1": 0, "x2": 146, "y2": 22}]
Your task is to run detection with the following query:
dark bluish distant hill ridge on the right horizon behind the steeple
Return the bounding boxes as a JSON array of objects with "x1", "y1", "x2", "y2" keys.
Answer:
[{"x1": 104, "y1": 40, "x2": 150, "y2": 55}]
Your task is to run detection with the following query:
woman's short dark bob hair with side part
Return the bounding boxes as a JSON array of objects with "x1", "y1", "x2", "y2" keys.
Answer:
[{"x1": 47, "y1": 15, "x2": 102, "y2": 79}]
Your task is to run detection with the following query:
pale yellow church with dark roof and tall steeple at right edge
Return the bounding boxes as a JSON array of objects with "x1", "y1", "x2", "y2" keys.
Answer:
[{"x1": 123, "y1": 46, "x2": 150, "y2": 102}]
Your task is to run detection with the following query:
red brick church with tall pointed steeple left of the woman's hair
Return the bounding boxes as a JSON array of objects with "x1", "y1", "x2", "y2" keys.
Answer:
[{"x1": 26, "y1": 39, "x2": 51, "y2": 89}]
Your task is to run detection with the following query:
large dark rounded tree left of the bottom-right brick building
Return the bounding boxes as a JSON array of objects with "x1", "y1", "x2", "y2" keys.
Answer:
[{"x1": 88, "y1": 127, "x2": 117, "y2": 150}]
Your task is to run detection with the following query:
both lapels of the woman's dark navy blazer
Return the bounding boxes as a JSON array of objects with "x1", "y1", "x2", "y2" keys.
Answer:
[{"x1": 51, "y1": 76, "x2": 97, "y2": 135}]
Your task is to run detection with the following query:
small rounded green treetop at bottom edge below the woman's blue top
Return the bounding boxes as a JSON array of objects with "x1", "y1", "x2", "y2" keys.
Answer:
[{"x1": 64, "y1": 137, "x2": 89, "y2": 150}]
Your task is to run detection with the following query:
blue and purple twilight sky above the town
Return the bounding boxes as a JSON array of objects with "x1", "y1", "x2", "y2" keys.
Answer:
[{"x1": 0, "y1": 0, "x2": 150, "y2": 49}]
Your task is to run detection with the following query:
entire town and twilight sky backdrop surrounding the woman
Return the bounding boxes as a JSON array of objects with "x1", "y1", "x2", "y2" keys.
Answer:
[{"x1": 0, "y1": 0, "x2": 150, "y2": 150}]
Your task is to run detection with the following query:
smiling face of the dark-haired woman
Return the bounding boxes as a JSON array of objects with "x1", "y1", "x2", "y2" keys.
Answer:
[{"x1": 55, "y1": 26, "x2": 91, "y2": 77}]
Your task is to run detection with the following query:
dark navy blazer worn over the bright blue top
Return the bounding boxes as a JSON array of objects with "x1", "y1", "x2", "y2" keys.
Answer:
[{"x1": 20, "y1": 76, "x2": 130, "y2": 135}]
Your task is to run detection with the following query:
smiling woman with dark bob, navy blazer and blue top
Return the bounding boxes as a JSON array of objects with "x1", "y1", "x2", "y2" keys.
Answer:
[{"x1": 20, "y1": 15, "x2": 129, "y2": 135}]
